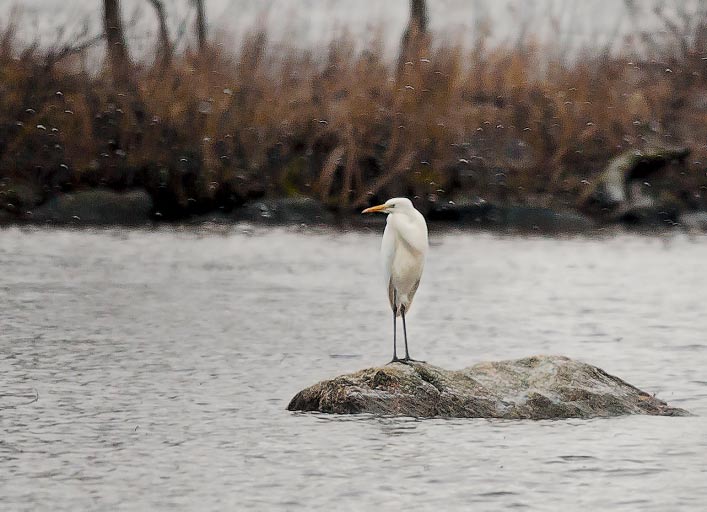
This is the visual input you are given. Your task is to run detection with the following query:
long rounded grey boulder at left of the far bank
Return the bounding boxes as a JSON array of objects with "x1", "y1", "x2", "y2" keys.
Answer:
[{"x1": 30, "y1": 189, "x2": 152, "y2": 225}]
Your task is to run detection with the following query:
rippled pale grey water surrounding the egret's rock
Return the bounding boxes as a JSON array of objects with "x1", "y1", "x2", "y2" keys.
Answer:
[{"x1": 0, "y1": 226, "x2": 707, "y2": 511}]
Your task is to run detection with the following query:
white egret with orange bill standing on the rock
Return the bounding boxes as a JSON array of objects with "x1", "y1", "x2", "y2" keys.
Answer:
[{"x1": 362, "y1": 197, "x2": 429, "y2": 362}]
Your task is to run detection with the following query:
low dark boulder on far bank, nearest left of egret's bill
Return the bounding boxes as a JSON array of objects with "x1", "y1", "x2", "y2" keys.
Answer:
[{"x1": 235, "y1": 197, "x2": 334, "y2": 224}]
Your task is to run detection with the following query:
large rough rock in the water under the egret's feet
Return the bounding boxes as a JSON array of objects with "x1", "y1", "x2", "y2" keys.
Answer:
[{"x1": 287, "y1": 356, "x2": 690, "y2": 420}]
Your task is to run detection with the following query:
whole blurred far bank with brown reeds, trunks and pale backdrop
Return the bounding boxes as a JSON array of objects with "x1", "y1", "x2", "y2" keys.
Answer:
[{"x1": 0, "y1": 0, "x2": 707, "y2": 230}]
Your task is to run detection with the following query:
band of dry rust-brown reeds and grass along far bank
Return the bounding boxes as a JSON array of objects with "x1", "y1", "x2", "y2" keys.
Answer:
[{"x1": 0, "y1": 2, "x2": 707, "y2": 218}]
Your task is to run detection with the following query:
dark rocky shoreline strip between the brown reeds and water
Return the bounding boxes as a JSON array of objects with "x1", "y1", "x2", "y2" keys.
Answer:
[{"x1": 0, "y1": 190, "x2": 707, "y2": 237}]
